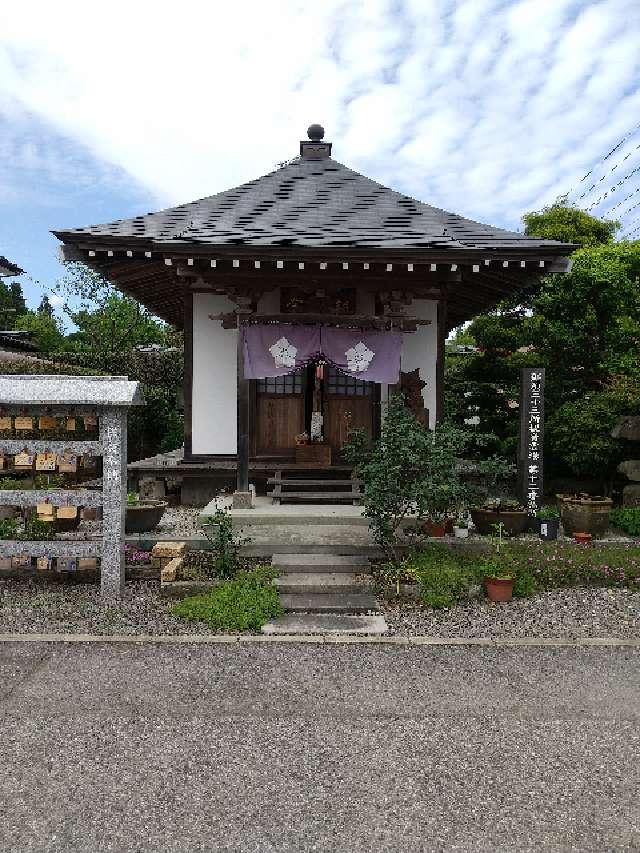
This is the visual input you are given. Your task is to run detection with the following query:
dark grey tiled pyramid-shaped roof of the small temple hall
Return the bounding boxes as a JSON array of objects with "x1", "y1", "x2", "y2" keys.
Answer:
[{"x1": 57, "y1": 158, "x2": 565, "y2": 250}]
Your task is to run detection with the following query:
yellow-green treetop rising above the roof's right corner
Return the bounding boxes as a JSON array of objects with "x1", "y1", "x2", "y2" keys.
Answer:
[{"x1": 522, "y1": 201, "x2": 620, "y2": 246}]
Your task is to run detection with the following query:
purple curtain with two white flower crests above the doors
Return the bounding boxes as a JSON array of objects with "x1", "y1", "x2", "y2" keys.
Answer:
[{"x1": 242, "y1": 323, "x2": 402, "y2": 384}]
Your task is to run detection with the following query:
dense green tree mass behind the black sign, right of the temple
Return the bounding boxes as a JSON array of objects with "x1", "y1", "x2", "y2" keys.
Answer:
[{"x1": 446, "y1": 204, "x2": 640, "y2": 484}]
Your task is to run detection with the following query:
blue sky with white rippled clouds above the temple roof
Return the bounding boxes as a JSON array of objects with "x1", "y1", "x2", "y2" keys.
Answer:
[{"x1": 0, "y1": 0, "x2": 640, "y2": 314}]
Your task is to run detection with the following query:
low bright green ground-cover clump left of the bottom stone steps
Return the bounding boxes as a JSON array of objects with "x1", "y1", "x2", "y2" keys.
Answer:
[{"x1": 172, "y1": 567, "x2": 282, "y2": 631}]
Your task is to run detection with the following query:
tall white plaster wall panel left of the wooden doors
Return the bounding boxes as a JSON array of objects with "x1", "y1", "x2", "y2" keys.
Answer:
[{"x1": 191, "y1": 293, "x2": 238, "y2": 454}]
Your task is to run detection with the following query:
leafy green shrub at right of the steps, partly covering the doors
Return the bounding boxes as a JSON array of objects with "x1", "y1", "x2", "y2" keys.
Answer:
[{"x1": 344, "y1": 395, "x2": 504, "y2": 556}]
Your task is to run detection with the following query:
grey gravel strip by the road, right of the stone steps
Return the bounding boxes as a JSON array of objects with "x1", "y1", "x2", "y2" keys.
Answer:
[{"x1": 383, "y1": 589, "x2": 640, "y2": 637}]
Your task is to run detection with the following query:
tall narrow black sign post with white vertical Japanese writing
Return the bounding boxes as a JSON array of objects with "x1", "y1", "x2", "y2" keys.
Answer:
[{"x1": 519, "y1": 367, "x2": 544, "y2": 518}]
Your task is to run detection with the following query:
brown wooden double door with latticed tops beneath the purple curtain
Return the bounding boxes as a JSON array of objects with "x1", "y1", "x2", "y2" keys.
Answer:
[{"x1": 254, "y1": 365, "x2": 380, "y2": 459}]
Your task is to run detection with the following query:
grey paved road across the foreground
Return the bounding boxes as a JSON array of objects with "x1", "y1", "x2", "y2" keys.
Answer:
[{"x1": 0, "y1": 644, "x2": 640, "y2": 853}]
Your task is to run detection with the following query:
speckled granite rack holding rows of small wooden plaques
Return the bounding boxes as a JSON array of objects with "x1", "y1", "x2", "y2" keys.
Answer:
[{"x1": 0, "y1": 375, "x2": 142, "y2": 598}]
